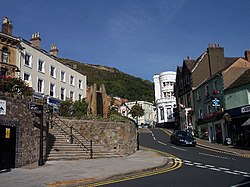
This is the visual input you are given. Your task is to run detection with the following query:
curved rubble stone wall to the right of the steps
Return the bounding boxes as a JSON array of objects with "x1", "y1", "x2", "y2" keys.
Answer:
[{"x1": 62, "y1": 119, "x2": 137, "y2": 156}]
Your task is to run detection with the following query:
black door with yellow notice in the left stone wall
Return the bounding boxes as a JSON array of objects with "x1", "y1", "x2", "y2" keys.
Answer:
[{"x1": 0, "y1": 125, "x2": 16, "y2": 170}]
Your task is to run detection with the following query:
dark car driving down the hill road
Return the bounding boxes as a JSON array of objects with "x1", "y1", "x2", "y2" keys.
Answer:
[{"x1": 170, "y1": 130, "x2": 196, "y2": 146}]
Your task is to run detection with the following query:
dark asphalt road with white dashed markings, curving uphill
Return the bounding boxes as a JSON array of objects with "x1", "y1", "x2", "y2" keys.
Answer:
[{"x1": 106, "y1": 129, "x2": 250, "y2": 187}]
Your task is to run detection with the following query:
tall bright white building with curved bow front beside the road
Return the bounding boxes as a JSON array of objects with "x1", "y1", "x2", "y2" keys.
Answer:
[{"x1": 153, "y1": 71, "x2": 176, "y2": 125}]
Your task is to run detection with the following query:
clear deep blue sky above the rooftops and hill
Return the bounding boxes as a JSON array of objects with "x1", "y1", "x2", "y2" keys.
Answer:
[{"x1": 0, "y1": 0, "x2": 250, "y2": 81}]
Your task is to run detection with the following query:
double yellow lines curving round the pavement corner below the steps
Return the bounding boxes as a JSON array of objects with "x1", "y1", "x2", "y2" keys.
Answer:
[{"x1": 79, "y1": 147, "x2": 182, "y2": 187}]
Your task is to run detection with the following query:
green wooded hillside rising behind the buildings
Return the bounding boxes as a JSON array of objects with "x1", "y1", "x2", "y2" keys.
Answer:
[{"x1": 58, "y1": 58, "x2": 154, "y2": 102}]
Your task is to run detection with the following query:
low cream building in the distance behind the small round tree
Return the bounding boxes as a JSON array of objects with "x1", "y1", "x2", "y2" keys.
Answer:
[{"x1": 126, "y1": 101, "x2": 156, "y2": 127}]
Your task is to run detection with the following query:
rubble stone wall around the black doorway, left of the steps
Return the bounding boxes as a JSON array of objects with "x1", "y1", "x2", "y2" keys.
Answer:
[{"x1": 0, "y1": 94, "x2": 46, "y2": 167}]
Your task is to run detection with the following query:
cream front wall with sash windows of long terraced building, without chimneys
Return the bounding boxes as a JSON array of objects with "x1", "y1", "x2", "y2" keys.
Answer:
[{"x1": 17, "y1": 37, "x2": 86, "y2": 104}]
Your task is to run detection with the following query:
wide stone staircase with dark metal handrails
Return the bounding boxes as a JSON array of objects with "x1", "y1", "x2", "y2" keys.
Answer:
[{"x1": 47, "y1": 118, "x2": 122, "y2": 160}]
